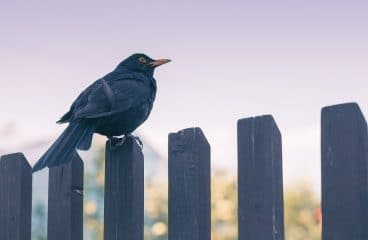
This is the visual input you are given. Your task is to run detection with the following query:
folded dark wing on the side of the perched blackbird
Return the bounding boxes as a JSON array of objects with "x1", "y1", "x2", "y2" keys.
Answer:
[{"x1": 74, "y1": 77, "x2": 150, "y2": 119}]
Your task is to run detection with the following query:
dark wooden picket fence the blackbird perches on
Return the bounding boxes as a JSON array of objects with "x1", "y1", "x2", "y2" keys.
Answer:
[{"x1": 0, "y1": 103, "x2": 368, "y2": 240}]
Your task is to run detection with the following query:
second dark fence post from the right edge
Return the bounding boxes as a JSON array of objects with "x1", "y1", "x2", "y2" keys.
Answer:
[{"x1": 238, "y1": 115, "x2": 284, "y2": 240}]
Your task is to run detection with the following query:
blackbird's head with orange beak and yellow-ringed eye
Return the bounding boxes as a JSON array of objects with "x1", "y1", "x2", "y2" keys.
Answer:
[{"x1": 118, "y1": 53, "x2": 170, "y2": 76}]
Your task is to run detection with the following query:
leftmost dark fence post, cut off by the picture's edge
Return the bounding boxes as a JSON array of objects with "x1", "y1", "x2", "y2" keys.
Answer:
[{"x1": 0, "y1": 153, "x2": 32, "y2": 240}]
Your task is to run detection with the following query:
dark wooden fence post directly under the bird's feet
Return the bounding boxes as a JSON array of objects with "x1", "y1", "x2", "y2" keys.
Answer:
[{"x1": 104, "y1": 138, "x2": 144, "y2": 240}]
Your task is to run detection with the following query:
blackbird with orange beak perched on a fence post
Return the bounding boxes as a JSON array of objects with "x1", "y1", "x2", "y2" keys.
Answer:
[{"x1": 33, "y1": 53, "x2": 170, "y2": 172}]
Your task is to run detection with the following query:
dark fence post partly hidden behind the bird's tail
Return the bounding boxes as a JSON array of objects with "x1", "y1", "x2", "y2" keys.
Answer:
[{"x1": 47, "y1": 153, "x2": 84, "y2": 240}]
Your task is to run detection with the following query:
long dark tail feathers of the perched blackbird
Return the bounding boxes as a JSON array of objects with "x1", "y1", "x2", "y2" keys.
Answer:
[{"x1": 33, "y1": 120, "x2": 95, "y2": 172}]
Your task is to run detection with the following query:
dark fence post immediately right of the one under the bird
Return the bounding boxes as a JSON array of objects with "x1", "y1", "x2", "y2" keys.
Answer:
[{"x1": 169, "y1": 128, "x2": 211, "y2": 240}]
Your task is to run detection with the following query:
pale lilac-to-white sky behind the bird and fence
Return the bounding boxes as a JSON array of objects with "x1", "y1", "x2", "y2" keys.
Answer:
[{"x1": 0, "y1": 0, "x2": 368, "y2": 191}]
